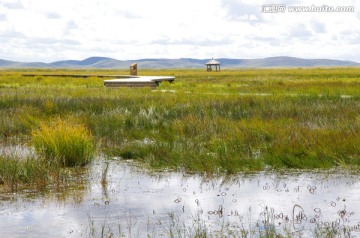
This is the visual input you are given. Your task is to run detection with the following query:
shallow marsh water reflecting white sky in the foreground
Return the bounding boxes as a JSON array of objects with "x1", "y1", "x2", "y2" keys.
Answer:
[{"x1": 0, "y1": 159, "x2": 360, "y2": 237}]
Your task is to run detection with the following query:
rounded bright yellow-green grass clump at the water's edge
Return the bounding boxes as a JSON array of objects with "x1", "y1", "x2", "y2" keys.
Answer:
[{"x1": 32, "y1": 118, "x2": 95, "y2": 167}]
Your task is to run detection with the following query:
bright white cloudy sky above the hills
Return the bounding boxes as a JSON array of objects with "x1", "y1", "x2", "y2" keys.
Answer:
[{"x1": 0, "y1": 0, "x2": 360, "y2": 63}]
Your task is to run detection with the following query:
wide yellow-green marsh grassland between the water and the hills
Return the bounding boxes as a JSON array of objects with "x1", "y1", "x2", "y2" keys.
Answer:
[{"x1": 0, "y1": 68, "x2": 360, "y2": 180}]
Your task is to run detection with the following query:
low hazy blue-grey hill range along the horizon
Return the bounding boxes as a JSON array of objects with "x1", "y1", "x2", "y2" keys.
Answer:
[{"x1": 0, "y1": 56, "x2": 360, "y2": 69}]
